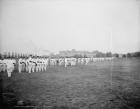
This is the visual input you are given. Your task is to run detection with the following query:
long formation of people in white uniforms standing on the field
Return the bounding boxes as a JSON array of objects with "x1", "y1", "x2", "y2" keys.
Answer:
[{"x1": 0, "y1": 56, "x2": 113, "y2": 77}]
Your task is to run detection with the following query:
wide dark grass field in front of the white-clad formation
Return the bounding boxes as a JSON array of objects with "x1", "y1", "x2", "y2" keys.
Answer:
[{"x1": 1, "y1": 58, "x2": 140, "y2": 109}]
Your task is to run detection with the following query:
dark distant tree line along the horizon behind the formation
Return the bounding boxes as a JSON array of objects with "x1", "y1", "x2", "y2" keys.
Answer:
[{"x1": 0, "y1": 51, "x2": 140, "y2": 58}]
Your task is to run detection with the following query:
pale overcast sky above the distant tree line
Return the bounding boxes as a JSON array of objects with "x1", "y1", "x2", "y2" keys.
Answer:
[{"x1": 0, "y1": 0, "x2": 140, "y2": 53}]
